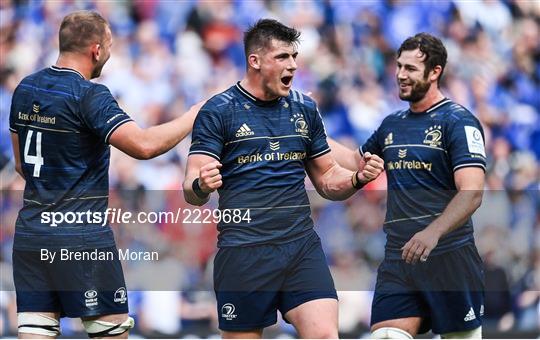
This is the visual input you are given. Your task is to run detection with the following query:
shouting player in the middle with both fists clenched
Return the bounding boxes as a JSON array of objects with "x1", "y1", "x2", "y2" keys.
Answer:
[{"x1": 184, "y1": 19, "x2": 383, "y2": 338}]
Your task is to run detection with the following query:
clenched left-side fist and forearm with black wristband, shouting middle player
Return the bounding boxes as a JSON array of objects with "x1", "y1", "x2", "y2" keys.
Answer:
[{"x1": 183, "y1": 154, "x2": 223, "y2": 206}]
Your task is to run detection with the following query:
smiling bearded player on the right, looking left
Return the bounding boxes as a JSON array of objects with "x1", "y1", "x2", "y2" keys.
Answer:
[{"x1": 330, "y1": 33, "x2": 486, "y2": 339}]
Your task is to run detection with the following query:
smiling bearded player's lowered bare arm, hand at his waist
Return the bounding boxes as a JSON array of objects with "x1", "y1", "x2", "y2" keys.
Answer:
[{"x1": 401, "y1": 167, "x2": 485, "y2": 263}]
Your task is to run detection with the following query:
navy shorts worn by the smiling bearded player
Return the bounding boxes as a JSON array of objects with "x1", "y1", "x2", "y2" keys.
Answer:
[{"x1": 371, "y1": 245, "x2": 484, "y2": 334}]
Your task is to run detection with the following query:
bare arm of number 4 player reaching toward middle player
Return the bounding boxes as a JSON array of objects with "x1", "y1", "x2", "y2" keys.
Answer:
[{"x1": 109, "y1": 102, "x2": 204, "y2": 159}]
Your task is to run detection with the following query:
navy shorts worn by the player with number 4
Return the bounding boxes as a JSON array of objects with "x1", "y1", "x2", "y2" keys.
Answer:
[{"x1": 13, "y1": 247, "x2": 128, "y2": 318}]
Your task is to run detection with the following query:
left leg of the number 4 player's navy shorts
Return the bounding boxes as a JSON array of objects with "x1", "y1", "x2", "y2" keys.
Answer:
[{"x1": 13, "y1": 250, "x2": 61, "y2": 313}]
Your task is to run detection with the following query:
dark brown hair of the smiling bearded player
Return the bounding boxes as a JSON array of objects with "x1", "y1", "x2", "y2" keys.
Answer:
[{"x1": 397, "y1": 32, "x2": 448, "y2": 84}]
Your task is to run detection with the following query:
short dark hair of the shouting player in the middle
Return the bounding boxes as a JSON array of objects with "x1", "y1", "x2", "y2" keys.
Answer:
[{"x1": 244, "y1": 19, "x2": 300, "y2": 58}]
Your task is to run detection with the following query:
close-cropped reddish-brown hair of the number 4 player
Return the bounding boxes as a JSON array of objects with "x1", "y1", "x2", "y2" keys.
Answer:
[{"x1": 58, "y1": 11, "x2": 109, "y2": 53}]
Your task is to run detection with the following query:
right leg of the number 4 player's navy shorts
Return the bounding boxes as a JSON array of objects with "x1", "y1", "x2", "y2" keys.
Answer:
[{"x1": 51, "y1": 247, "x2": 128, "y2": 317}]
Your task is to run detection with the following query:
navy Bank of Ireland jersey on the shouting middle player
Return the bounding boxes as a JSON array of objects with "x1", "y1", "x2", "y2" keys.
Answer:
[{"x1": 190, "y1": 83, "x2": 330, "y2": 247}]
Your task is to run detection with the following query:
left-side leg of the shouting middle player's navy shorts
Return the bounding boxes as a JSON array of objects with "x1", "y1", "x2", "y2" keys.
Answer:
[{"x1": 214, "y1": 245, "x2": 285, "y2": 330}]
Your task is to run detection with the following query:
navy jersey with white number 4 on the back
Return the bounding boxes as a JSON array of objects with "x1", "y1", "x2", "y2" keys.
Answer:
[{"x1": 9, "y1": 66, "x2": 131, "y2": 250}]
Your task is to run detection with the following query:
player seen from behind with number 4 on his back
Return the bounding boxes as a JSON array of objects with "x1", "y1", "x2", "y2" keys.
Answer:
[{"x1": 9, "y1": 11, "x2": 202, "y2": 338}]
